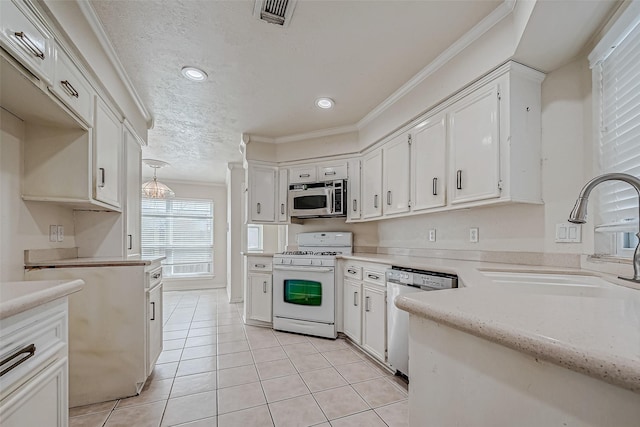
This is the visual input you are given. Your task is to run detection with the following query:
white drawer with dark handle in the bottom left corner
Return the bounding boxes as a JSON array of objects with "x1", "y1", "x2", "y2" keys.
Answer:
[{"x1": 0, "y1": 301, "x2": 68, "y2": 400}]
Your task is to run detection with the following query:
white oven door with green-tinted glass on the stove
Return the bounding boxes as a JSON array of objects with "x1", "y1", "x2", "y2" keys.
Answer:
[{"x1": 273, "y1": 265, "x2": 335, "y2": 324}]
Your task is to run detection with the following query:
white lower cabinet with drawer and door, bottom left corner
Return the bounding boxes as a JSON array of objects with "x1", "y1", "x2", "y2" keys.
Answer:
[{"x1": 0, "y1": 298, "x2": 69, "y2": 427}]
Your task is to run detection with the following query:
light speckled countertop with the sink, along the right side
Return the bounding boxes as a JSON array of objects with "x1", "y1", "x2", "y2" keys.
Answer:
[{"x1": 341, "y1": 254, "x2": 640, "y2": 393}]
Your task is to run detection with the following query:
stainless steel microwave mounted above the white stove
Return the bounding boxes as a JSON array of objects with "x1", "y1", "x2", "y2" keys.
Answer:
[{"x1": 289, "y1": 179, "x2": 347, "y2": 218}]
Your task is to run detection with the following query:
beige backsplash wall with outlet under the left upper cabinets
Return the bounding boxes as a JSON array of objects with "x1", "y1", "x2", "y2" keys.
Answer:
[{"x1": 0, "y1": 109, "x2": 75, "y2": 281}]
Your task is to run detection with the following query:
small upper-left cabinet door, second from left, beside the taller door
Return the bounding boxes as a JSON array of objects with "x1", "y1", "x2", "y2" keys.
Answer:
[{"x1": 50, "y1": 45, "x2": 95, "y2": 126}]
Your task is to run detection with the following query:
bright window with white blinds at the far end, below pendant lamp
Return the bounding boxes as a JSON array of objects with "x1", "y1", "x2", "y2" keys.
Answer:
[{"x1": 142, "y1": 198, "x2": 213, "y2": 278}]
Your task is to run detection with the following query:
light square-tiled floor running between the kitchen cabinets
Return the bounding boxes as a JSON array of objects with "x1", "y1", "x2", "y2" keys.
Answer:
[{"x1": 69, "y1": 290, "x2": 408, "y2": 427}]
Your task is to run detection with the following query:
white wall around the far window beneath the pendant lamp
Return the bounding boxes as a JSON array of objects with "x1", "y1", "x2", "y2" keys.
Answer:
[{"x1": 160, "y1": 179, "x2": 227, "y2": 290}]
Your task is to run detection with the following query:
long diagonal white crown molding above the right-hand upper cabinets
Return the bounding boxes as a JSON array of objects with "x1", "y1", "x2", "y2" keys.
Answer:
[{"x1": 355, "y1": 0, "x2": 517, "y2": 129}]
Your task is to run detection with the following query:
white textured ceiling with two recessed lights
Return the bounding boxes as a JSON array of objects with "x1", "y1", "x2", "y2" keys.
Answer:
[{"x1": 91, "y1": 0, "x2": 501, "y2": 182}]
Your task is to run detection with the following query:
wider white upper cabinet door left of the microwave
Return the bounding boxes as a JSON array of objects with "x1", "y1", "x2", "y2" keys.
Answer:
[{"x1": 249, "y1": 165, "x2": 277, "y2": 223}]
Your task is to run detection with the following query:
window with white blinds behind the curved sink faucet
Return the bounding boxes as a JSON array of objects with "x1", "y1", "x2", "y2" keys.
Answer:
[{"x1": 593, "y1": 6, "x2": 640, "y2": 256}]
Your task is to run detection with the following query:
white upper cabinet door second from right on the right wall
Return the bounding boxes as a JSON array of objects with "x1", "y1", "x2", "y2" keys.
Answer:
[{"x1": 411, "y1": 114, "x2": 446, "y2": 212}]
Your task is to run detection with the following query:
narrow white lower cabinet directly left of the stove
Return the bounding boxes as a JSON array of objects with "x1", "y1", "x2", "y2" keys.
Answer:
[{"x1": 244, "y1": 256, "x2": 273, "y2": 326}]
